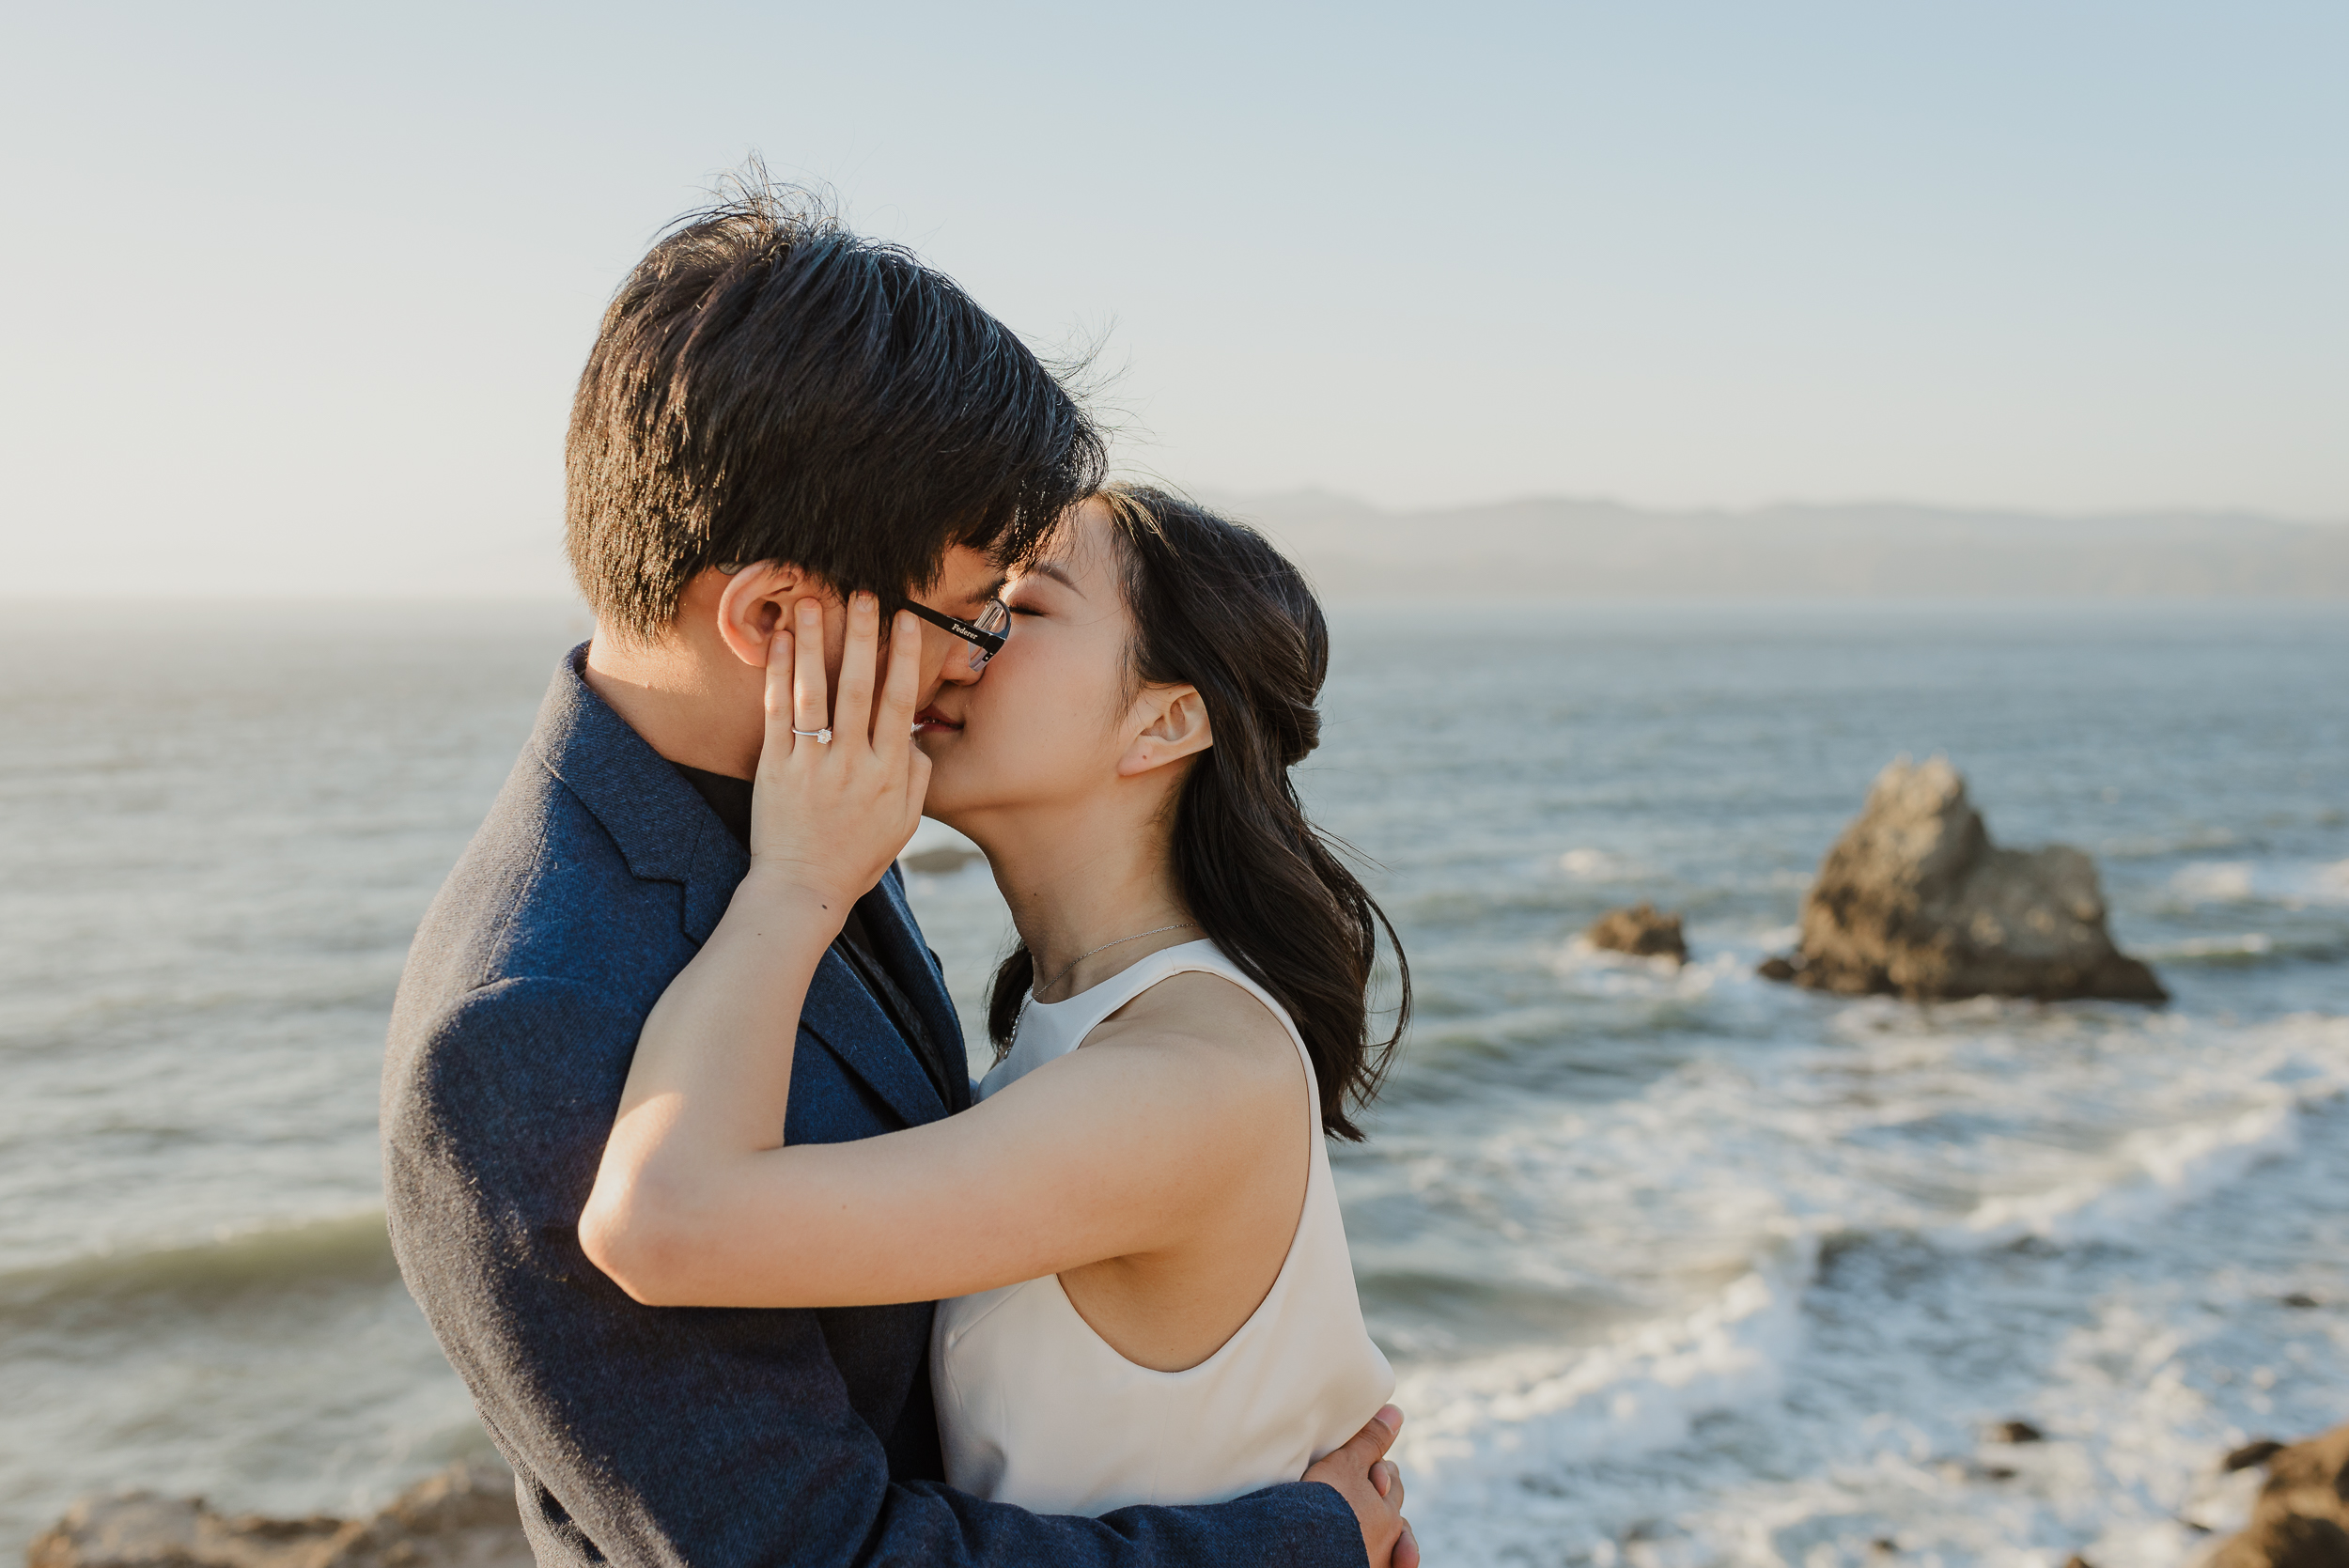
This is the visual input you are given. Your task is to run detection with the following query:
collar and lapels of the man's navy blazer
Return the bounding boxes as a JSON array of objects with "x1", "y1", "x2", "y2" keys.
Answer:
[{"x1": 531, "y1": 644, "x2": 963, "y2": 1125}]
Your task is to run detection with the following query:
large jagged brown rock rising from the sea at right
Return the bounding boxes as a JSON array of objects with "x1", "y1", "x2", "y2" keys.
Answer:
[{"x1": 1762, "y1": 758, "x2": 2169, "y2": 1002}]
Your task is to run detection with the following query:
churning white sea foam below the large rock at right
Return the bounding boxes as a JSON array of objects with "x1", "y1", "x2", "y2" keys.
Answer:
[{"x1": 1398, "y1": 1009, "x2": 2349, "y2": 1568}]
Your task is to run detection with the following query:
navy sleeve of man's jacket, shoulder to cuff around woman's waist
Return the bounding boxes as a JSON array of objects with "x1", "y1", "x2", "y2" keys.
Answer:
[{"x1": 383, "y1": 979, "x2": 1362, "y2": 1568}]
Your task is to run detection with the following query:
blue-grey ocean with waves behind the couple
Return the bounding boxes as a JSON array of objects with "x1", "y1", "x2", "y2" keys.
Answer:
[{"x1": 0, "y1": 603, "x2": 2349, "y2": 1568}]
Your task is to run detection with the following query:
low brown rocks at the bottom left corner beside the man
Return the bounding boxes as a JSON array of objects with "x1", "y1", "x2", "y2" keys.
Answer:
[{"x1": 26, "y1": 1465, "x2": 531, "y2": 1568}]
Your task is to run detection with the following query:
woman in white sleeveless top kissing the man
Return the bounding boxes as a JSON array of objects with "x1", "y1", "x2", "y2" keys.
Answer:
[{"x1": 581, "y1": 489, "x2": 1409, "y2": 1561}]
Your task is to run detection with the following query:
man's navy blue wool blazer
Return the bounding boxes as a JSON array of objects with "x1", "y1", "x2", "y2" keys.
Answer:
[{"x1": 383, "y1": 648, "x2": 1362, "y2": 1568}]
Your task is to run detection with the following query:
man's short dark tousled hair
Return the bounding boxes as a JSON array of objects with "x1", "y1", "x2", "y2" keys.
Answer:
[{"x1": 564, "y1": 164, "x2": 1104, "y2": 639}]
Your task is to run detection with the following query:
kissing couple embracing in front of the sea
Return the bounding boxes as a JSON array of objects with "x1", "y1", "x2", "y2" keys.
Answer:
[{"x1": 383, "y1": 180, "x2": 1419, "y2": 1568}]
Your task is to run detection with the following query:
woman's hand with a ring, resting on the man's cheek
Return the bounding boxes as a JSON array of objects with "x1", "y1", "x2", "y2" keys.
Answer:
[{"x1": 750, "y1": 594, "x2": 930, "y2": 920}]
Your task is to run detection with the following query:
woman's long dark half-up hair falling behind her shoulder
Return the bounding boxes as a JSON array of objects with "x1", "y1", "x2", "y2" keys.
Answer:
[{"x1": 987, "y1": 484, "x2": 1412, "y2": 1141}]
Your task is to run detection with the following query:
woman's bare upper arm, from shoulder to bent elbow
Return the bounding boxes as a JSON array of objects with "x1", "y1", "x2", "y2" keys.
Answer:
[{"x1": 583, "y1": 976, "x2": 1304, "y2": 1308}]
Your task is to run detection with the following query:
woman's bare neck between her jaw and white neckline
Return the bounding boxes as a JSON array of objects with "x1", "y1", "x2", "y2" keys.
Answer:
[{"x1": 966, "y1": 788, "x2": 1198, "y2": 1002}]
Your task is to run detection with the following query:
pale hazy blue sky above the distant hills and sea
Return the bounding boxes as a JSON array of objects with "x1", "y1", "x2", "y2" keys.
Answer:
[{"x1": 0, "y1": 0, "x2": 2349, "y2": 594}]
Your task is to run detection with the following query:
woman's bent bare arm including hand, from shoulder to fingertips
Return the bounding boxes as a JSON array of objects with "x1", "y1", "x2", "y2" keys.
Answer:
[{"x1": 581, "y1": 597, "x2": 1299, "y2": 1308}]
